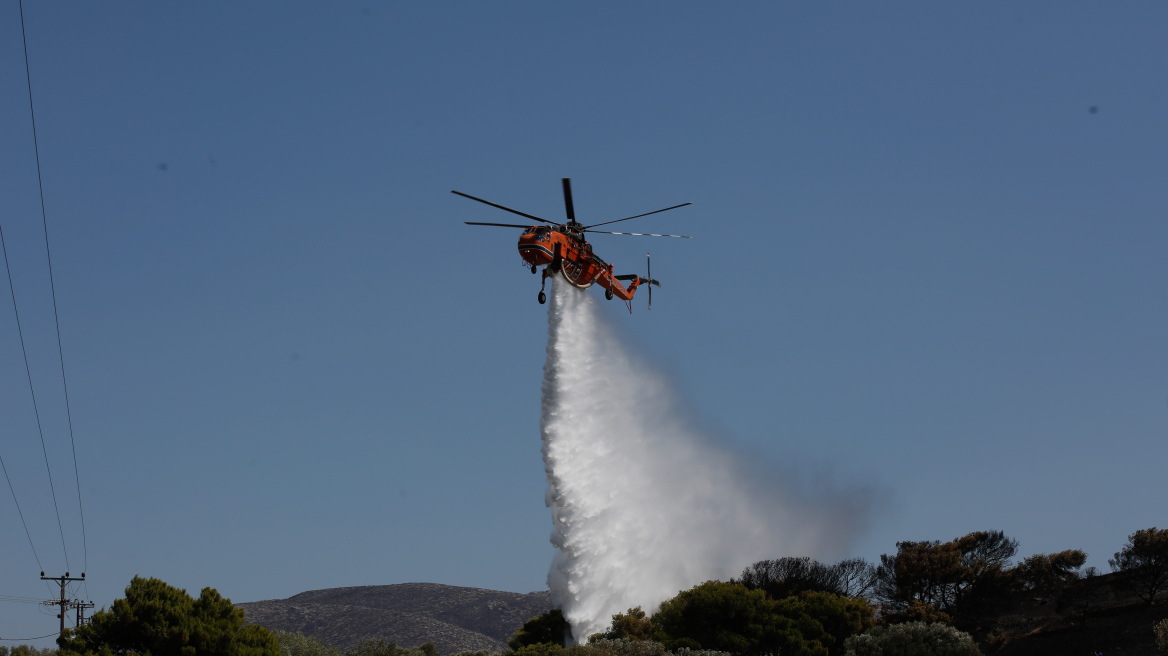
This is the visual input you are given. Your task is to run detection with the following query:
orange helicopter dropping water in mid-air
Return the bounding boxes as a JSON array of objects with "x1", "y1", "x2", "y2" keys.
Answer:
[{"x1": 451, "y1": 177, "x2": 693, "y2": 312}]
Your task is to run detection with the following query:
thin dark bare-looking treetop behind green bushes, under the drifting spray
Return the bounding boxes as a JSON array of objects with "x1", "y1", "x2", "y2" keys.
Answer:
[{"x1": 731, "y1": 557, "x2": 876, "y2": 599}]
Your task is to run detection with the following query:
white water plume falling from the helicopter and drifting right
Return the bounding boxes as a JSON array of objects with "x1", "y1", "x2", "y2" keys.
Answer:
[{"x1": 541, "y1": 278, "x2": 865, "y2": 642}]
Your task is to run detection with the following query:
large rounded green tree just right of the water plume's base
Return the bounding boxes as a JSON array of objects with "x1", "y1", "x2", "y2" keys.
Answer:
[{"x1": 653, "y1": 581, "x2": 829, "y2": 656}]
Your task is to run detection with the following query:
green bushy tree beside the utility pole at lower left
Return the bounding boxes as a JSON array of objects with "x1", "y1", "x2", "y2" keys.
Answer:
[{"x1": 57, "y1": 577, "x2": 280, "y2": 656}]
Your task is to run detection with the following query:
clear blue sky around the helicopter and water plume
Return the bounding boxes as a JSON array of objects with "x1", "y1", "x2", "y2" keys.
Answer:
[{"x1": 0, "y1": 1, "x2": 1168, "y2": 637}]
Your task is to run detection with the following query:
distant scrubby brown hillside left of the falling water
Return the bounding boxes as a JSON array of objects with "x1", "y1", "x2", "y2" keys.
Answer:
[{"x1": 237, "y1": 584, "x2": 551, "y2": 654}]
